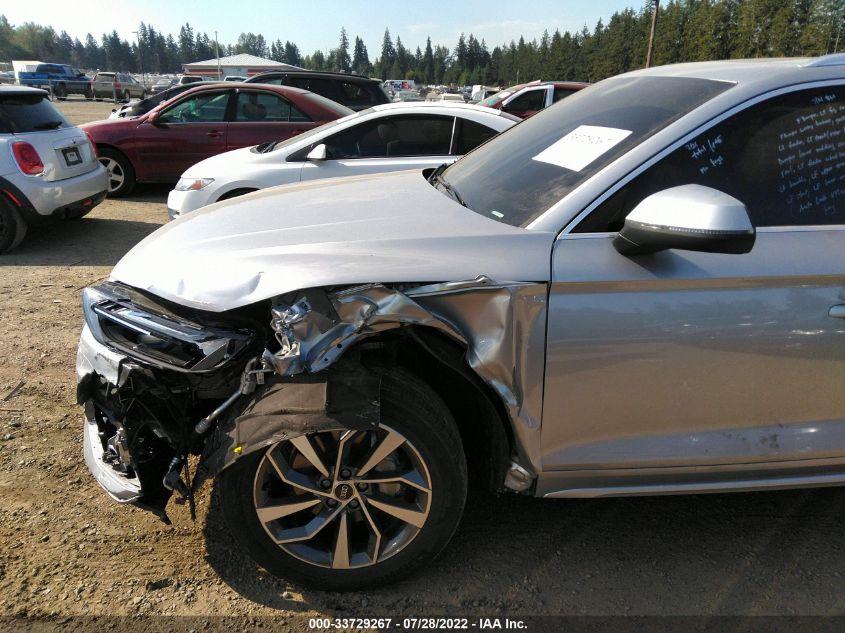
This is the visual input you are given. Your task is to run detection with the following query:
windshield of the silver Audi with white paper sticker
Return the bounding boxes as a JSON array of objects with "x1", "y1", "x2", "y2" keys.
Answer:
[{"x1": 442, "y1": 77, "x2": 733, "y2": 227}]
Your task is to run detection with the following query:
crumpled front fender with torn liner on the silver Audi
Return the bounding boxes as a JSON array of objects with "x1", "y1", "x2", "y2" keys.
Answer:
[{"x1": 199, "y1": 277, "x2": 547, "y2": 486}]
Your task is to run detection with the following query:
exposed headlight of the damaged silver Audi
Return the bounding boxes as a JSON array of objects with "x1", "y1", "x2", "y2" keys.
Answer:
[{"x1": 82, "y1": 282, "x2": 254, "y2": 372}]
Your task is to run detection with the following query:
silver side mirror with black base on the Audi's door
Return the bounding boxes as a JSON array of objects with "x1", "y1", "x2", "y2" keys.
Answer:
[{"x1": 613, "y1": 185, "x2": 756, "y2": 255}]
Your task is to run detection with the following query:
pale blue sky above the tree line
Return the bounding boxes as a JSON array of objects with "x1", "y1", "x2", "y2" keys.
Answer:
[{"x1": 0, "y1": 0, "x2": 642, "y2": 58}]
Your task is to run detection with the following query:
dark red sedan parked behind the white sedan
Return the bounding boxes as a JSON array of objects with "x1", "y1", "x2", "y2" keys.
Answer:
[{"x1": 80, "y1": 83, "x2": 353, "y2": 196}]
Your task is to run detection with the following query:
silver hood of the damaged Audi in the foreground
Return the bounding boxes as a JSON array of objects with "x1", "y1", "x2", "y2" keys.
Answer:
[{"x1": 111, "y1": 171, "x2": 555, "y2": 312}]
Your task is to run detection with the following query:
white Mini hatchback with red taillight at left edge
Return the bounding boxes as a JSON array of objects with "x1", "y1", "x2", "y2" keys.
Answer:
[{"x1": 0, "y1": 86, "x2": 108, "y2": 254}]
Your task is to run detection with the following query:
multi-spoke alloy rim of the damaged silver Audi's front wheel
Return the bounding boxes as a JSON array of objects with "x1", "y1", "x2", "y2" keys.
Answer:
[{"x1": 253, "y1": 425, "x2": 432, "y2": 569}]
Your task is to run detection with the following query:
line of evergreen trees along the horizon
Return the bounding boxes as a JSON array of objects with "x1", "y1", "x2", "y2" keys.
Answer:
[{"x1": 0, "y1": 0, "x2": 845, "y2": 85}]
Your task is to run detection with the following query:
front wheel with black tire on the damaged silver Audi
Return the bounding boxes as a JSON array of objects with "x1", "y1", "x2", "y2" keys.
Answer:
[{"x1": 219, "y1": 368, "x2": 467, "y2": 591}]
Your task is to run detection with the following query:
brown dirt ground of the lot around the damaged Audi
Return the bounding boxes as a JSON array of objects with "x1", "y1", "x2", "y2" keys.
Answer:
[{"x1": 0, "y1": 101, "x2": 845, "y2": 630}]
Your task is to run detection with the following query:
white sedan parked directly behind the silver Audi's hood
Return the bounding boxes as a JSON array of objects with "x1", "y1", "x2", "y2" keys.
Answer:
[{"x1": 167, "y1": 102, "x2": 520, "y2": 219}]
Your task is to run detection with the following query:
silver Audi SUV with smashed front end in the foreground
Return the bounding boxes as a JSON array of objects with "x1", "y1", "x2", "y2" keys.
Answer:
[{"x1": 77, "y1": 55, "x2": 845, "y2": 590}]
